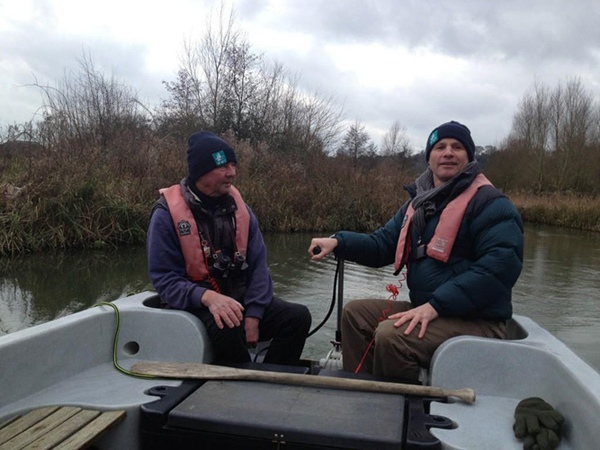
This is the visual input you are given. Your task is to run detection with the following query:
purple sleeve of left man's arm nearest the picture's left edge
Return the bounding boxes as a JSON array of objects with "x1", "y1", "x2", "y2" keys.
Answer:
[{"x1": 146, "y1": 208, "x2": 205, "y2": 310}]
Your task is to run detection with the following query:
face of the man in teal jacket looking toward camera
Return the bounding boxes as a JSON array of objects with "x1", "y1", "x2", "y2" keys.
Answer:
[{"x1": 429, "y1": 138, "x2": 469, "y2": 187}]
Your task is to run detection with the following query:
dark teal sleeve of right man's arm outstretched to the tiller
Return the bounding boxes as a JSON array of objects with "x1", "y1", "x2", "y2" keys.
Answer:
[{"x1": 335, "y1": 202, "x2": 408, "y2": 267}]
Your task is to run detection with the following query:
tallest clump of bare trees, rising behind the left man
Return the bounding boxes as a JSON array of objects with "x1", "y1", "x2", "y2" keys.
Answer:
[{"x1": 160, "y1": 5, "x2": 343, "y2": 157}]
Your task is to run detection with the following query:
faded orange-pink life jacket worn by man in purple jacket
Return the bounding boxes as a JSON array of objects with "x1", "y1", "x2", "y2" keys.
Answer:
[{"x1": 159, "y1": 184, "x2": 250, "y2": 281}]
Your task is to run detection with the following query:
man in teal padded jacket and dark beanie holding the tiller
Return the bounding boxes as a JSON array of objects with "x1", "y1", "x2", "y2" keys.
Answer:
[{"x1": 309, "y1": 121, "x2": 523, "y2": 381}]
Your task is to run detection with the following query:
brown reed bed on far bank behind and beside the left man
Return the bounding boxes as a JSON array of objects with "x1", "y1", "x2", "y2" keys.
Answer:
[{"x1": 0, "y1": 137, "x2": 412, "y2": 255}]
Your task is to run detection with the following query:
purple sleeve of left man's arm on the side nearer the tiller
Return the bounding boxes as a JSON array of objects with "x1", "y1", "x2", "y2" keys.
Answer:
[{"x1": 244, "y1": 207, "x2": 273, "y2": 319}]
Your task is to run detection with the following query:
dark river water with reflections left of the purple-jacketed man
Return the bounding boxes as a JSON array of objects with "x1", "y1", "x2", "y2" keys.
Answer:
[{"x1": 0, "y1": 248, "x2": 150, "y2": 334}]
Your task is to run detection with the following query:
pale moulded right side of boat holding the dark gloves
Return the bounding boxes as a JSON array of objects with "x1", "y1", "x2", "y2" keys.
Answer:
[{"x1": 430, "y1": 316, "x2": 600, "y2": 450}]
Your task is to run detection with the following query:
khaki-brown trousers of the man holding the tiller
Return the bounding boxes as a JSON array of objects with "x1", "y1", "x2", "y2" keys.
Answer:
[{"x1": 342, "y1": 299, "x2": 506, "y2": 381}]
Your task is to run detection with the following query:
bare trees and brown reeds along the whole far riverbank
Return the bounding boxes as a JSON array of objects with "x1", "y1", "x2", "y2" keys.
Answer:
[{"x1": 0, "y1": 9, "x2": 600, "y2": 255}]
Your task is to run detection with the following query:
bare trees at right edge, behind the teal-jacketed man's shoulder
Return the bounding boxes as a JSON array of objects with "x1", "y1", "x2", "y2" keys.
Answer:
[{"x1": 494, "y1": 78, "x2": 600, "y2": 192}]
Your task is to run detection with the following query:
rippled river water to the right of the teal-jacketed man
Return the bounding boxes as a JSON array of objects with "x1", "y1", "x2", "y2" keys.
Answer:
[{"x1": 513, "y1": 225, "x2": 600, "y2": 369}]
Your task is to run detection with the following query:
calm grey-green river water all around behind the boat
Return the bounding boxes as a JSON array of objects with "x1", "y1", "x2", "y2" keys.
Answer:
[{"x1": 0, "y1": 225, "x2": 600, "y2": 371}]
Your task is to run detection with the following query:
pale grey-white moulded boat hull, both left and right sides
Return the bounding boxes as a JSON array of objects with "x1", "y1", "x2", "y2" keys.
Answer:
[{"x1": 0, "y1": 292, "x2": 600, "y2": 450}]
